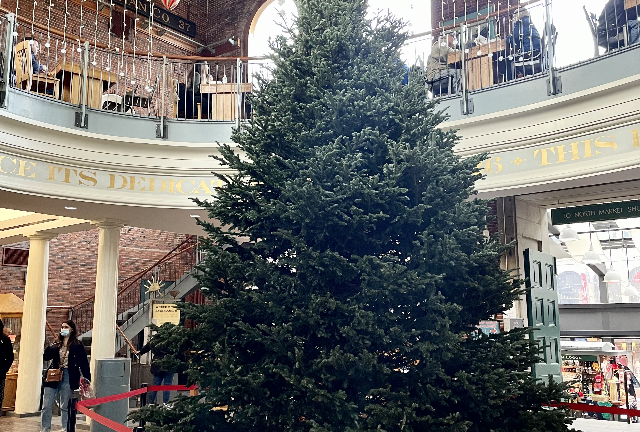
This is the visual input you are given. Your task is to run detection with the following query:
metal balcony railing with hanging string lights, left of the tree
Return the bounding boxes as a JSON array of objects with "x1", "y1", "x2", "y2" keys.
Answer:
[{"x1": 0, "y1": 8, "x2": 270, "y2": 126}]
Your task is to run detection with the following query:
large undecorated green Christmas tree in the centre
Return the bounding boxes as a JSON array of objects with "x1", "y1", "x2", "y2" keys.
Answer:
[{"x1": 138, "y1": 0, "x2": 567, "y2": 432}]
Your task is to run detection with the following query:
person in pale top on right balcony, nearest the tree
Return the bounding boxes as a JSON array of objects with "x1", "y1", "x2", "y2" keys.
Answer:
[{"x1": 426, "y1": 33, "x2": 462, "y2": 96}]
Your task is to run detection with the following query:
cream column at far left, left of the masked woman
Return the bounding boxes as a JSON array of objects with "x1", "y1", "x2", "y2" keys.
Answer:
[{"x1": 15, "y1": 233, "x2": 57, "y2": 414}]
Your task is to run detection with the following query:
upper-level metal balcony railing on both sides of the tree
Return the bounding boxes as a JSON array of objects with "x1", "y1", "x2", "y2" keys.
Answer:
[{"x1": 0, "y1": 0, "x2": 640, "y2": 128}]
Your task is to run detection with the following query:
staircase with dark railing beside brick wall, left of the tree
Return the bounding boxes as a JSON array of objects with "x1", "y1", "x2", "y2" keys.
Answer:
[{"x1": 70, "y1": 236, "x2": 201, "y2": 353}]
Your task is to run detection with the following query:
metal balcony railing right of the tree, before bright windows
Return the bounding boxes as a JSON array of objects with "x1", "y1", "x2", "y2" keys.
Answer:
[{"x1": 409, "y1": 0, "x2": 640, "y2": 104}]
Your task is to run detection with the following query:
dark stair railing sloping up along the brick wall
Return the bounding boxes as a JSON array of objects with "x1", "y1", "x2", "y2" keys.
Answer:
[{"x1": 70, "y1": 236, "x2": 199, "y2": 335}]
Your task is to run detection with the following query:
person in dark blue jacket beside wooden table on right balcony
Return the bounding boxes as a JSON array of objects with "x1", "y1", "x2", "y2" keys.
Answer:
[{"x1": 507, "y1": 7, "x2": 542, "y2": 78}]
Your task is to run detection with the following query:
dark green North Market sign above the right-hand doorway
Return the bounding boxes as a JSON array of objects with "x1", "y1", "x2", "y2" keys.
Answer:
[{"x1": 551, "y1": 201, "x2": 640, "y2": 225}]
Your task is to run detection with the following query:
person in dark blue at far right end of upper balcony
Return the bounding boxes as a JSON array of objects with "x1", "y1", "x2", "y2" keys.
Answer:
[{"x1": 597, "y1": 0, "x2": 640, "y2": 51}]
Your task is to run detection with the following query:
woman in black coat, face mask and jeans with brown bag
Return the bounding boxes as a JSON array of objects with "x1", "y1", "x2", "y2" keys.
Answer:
[{"x1": 42, "y1": 320, "x2": 91, "y2": 432}]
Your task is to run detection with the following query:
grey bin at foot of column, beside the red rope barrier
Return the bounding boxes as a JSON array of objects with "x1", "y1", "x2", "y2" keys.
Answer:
[{"x1": 91, "y1": 358, "x2": 131, "y2": 432}]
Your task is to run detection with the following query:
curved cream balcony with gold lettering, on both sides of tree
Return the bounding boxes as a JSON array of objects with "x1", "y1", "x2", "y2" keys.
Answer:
[{"x1": 0, "y1": 0, "x2": 640, "y2": 223}]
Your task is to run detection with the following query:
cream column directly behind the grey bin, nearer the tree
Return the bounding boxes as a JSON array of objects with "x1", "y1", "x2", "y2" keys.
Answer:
[{"x1": 91, "y1": 219, "x2": 124, "y2": 374}]
